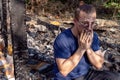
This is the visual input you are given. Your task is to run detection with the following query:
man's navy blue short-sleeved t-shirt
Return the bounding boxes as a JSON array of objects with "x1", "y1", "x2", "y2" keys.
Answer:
[{"x1": 54, "y1": 29, "x2": 99, "y2": 80}]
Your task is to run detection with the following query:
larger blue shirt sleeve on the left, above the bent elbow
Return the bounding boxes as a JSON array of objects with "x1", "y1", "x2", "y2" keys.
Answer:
[{"x1": 53, "y1": 35, "x2": 71, "y2": 59}]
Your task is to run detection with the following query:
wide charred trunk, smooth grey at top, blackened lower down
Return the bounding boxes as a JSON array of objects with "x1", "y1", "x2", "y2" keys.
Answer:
[{"x1": 11, "y1": 0, "x2": 29, "y2": 80}]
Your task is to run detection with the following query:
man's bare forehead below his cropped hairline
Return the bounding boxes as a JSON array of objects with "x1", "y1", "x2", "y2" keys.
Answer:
[{"x1": 79, "y1": 11, "x2": 96, "y2": 19}]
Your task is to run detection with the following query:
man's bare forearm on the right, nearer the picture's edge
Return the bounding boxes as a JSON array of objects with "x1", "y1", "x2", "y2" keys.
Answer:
[{"x1": 87, "y1": 49, "x2": 104, "y2": 69}]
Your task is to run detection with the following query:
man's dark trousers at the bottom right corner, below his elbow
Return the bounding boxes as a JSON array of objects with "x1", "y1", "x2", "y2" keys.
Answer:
[{"x1": 74, "y1": 70, "x2": 120, "y2": 80}]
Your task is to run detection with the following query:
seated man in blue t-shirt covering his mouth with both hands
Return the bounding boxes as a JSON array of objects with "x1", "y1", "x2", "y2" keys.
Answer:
[{"x1": 54, "y1": 4, "x2": 120, "y2": 80}]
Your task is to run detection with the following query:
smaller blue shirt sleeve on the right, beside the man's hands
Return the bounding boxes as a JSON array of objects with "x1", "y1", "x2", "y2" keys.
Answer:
[{"x1": 92, "y1": 33, "x2": 100, "y2": 51}]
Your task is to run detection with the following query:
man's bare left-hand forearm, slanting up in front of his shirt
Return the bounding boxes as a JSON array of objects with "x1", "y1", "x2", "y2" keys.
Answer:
[{"x1": 59, "y1": 49, "x2": 85, "y2": 76}]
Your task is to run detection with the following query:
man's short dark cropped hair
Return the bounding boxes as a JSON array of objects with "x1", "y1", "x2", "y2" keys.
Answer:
[{"x1": 75, "y1": 4, "x2": 96, "y2": 20}]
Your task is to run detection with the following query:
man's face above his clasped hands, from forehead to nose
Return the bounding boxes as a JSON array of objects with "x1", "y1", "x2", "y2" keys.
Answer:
[{"x1": 75, "y1": 11, "x2": 96, "y2": 33}]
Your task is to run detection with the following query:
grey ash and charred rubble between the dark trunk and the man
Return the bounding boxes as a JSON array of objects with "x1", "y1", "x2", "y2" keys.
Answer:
[{"x1": 26, "y1": 17, "x2": 64, "y2": 80}]
